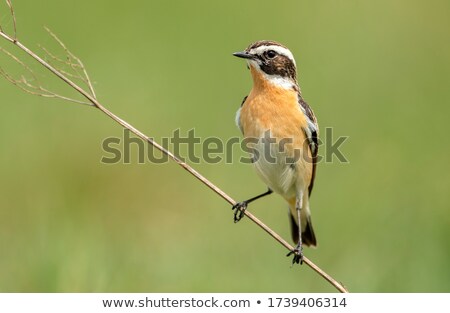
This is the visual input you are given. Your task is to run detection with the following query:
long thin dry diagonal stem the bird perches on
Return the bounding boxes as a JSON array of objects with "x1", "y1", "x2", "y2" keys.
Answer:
[{"x1": 0, "y1": 27, "x2": 348, "y2": 293}]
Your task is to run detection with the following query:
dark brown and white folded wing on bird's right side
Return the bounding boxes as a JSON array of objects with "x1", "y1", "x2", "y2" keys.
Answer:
[{"x1": 298, "y1": 94, "x2": 319, "y2": 195}]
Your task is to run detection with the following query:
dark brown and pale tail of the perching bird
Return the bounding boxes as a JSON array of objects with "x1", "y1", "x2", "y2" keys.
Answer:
[{"x1": 289, "y1": 199, "x2": 317, "y2": 247}]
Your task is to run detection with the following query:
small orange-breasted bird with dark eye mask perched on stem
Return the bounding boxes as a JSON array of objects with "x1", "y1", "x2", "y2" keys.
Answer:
[{"x1": 233, "y1": 40, "x2": 319, "y2": 264}]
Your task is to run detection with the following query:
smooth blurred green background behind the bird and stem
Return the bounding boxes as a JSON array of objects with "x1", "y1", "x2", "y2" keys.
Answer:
[{"x1": 0, "y1": 0, "x2": 450, "y2": 292}]
